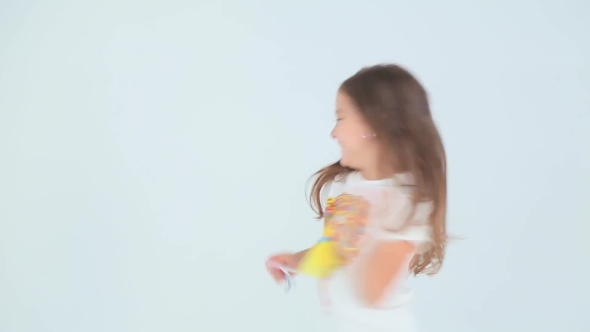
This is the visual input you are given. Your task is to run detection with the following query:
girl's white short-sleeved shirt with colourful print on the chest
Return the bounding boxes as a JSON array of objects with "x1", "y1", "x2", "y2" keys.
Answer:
[{"x1": 324, "y1": 173, "x2": 432, "y2": 332}]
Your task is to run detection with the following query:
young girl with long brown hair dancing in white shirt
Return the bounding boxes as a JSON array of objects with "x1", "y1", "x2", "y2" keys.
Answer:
[{"x1": 268, "y1": 65, "x2": 447, "y2": 332}]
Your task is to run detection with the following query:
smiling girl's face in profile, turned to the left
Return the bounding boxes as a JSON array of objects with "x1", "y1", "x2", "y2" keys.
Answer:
[{"x1": 332, "y1": 92, "x2": 378, "y2": 170}]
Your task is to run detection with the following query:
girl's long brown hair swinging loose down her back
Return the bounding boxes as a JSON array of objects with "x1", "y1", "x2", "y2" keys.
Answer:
[{"x1": 310, "y1": 65, "x2": 448, "y2": 275}]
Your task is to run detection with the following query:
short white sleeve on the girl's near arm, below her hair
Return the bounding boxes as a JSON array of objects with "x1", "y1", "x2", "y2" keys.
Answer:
[{"x1": 350, "y1": 186, "x2": 433, "y2": 244}]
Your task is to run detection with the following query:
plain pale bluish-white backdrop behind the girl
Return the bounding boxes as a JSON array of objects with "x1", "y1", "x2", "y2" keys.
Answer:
[{"x1": 0, "y1": 0, "x2": 590, "y2": 332}]
